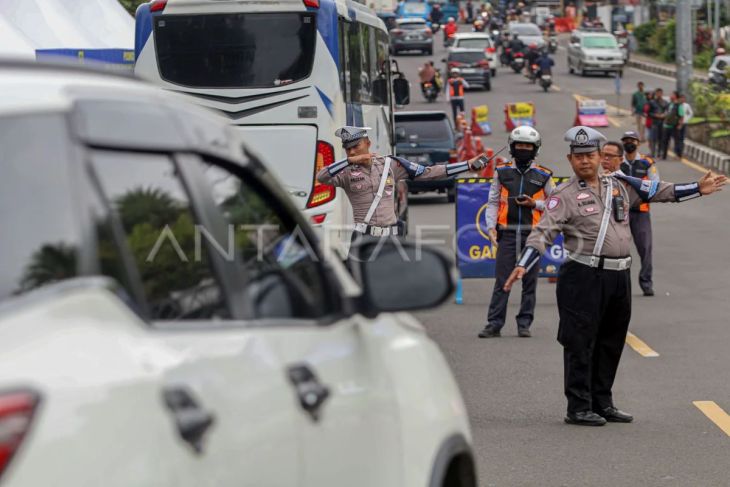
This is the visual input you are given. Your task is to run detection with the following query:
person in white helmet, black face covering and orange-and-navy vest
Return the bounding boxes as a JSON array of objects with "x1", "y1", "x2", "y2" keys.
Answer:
[{"x1": 479, "y1": 126, "x2": 555, "y2": 338}]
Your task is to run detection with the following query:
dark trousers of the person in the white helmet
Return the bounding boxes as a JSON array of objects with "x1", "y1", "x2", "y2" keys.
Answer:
[{"x1": 487, "y1": 230, "x2": 540, "y2": 330}]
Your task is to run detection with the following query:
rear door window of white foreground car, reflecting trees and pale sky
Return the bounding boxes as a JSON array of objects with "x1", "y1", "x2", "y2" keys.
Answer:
[{"x1": 92, "y1": 151, "x2": 230, "y2": 320}]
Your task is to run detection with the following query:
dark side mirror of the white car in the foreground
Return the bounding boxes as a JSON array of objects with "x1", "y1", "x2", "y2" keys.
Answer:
[{"x1": 350, "y1": 238, "x2": 456, "y2": 318}]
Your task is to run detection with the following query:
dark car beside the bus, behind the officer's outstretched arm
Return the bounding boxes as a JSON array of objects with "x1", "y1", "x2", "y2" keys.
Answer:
[{"x1": 395, "y1": 111, "x2": 456, "y2": 202}]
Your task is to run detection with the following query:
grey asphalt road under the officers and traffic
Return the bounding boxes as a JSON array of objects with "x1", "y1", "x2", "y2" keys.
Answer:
[{"x1": 398, "y1": 31, "x2": 730, "y2": 486}]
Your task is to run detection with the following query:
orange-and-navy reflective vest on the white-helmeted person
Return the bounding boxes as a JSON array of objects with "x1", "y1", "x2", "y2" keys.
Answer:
[{"x1": 496, "y1": 161, "x2": 553, "y2": 230}]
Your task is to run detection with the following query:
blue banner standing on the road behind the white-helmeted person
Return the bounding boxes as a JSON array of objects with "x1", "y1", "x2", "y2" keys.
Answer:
[{"x1": 456, "y1": 178, "x2": 568, "y2": 279}]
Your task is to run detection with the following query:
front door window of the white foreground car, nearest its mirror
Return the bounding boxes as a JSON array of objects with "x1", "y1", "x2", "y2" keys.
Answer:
[{"x1": 203, "y1": 160, "x2": 334, "y2": 319}]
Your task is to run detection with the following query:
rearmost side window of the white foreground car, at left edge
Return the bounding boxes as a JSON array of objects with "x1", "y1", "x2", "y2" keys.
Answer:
[{"x1": 0, "y1": 115, "x2": 81, "y2": 300}]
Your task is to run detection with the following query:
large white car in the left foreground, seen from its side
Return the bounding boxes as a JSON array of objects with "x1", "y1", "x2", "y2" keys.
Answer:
[{"x1": 0, "y1": 63, "x2": 477, "y2": 487}]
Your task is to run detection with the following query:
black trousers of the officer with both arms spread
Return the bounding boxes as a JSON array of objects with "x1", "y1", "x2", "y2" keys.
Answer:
[{"x1": 557, "y1": 260, "x2": 631, "y2": 413}]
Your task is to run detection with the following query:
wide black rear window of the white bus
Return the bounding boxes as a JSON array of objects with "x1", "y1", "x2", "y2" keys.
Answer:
[{"x1": 155, "y1": 12, "x2": 317, "y2": 88}]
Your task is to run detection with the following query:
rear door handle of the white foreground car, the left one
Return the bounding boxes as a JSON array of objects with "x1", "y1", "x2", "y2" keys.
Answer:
[{"x1": 163, "y1": 386, "x2": 215, "y2": 454}]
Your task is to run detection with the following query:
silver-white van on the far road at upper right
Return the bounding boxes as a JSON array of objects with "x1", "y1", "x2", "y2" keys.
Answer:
[{"x1": 568, "y1": 30, "x2": 625, "y2": 76}]
